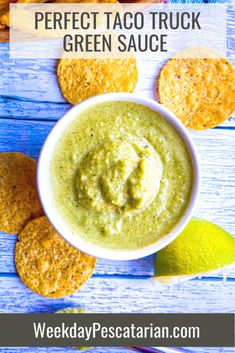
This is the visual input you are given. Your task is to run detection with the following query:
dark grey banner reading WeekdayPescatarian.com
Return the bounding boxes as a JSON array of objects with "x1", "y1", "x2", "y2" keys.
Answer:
[{"x1": 0, "y1": 314, "x2": 234, "y2": 347}]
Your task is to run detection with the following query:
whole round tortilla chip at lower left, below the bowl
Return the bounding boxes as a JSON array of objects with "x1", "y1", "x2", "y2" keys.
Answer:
[{"x1": 15, "y1": 216, "x2": 96, "y2": 298}]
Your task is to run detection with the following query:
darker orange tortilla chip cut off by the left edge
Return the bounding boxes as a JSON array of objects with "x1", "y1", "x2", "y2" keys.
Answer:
[{"x1": 0, "y1": 152, "x2": 43, "y2": 233}]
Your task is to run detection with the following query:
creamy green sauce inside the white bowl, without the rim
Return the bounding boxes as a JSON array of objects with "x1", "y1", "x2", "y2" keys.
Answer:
[{"x1": 50, "y1": 101, "x2": 193, "y2": 249}]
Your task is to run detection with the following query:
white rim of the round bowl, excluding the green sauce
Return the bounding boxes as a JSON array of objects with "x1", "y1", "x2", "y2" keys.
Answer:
[{"x1": 37, "y1": 93, "x2": 200, "y2": 260}]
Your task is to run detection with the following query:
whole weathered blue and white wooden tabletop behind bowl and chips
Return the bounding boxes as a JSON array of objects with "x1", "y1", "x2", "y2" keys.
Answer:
[{"x1": 0, "y1": 1, "x2": 235, "y2": 353}]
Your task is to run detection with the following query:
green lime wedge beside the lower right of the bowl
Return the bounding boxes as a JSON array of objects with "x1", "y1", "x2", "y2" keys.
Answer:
[{"x1": 154, "y1": 218, "x2": 235, "y2": 284}]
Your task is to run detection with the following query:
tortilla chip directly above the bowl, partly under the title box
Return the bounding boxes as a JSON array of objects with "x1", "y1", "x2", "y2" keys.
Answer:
[{"x1": 57, "y1": 58, "x2": 138, "y2": 104}]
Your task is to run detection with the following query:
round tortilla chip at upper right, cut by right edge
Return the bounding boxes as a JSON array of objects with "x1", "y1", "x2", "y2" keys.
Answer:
[{"x1": 158, "y1": 47, "x2": 235, "y2": 130}]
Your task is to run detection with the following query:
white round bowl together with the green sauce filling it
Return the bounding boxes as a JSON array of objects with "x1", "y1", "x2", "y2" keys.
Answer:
[{"x1": 37, "y1": 93, "x2": 200, "y2": 260}]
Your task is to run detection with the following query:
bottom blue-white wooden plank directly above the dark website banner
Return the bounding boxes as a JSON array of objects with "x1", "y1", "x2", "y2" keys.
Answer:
[{"x1": 0, "y1": 276, "x2": 235, "y2": 313}]
